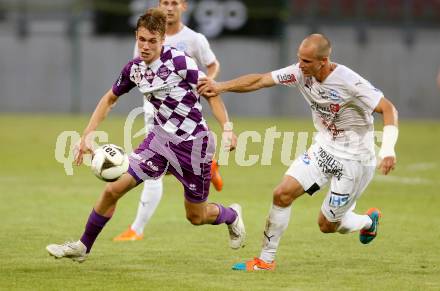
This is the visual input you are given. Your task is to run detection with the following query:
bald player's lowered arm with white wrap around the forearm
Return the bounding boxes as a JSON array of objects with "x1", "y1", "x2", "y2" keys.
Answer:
[{"x1": 374, "y1": 97, "x2": 399, "y2": 175}]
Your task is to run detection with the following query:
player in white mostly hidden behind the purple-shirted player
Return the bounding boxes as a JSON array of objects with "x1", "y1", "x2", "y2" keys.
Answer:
[{"x1": 113, "y1": 0, "x2": 230, "y2": 241}]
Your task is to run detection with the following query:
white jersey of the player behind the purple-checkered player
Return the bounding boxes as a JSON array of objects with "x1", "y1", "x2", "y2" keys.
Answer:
[{"x1": 133, "y1": 26, "x2": 216, "y2": 124}]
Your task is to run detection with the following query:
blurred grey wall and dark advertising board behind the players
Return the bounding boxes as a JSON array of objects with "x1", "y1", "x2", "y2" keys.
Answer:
[{"x1": 0, "y1": 0, "x2": 440, "y2": 119}]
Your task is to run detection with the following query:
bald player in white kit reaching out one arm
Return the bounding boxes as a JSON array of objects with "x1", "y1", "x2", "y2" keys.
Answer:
[{"x1": 198, "y1": 34, "x2": 398, "y2": 271}]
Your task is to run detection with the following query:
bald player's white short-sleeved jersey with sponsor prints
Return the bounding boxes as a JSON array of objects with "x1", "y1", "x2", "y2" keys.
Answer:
[{"x1": 272, "y1": 64, "x2": 383, "y2": 161}]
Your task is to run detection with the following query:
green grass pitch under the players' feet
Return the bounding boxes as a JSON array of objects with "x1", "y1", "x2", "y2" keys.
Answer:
[{"x1": 0, "y1": 115, "x2": 440, "y2": 290}]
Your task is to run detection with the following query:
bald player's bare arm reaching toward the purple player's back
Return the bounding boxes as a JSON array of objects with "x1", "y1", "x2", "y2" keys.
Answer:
[{"x1": 197, "y1": 73, "x2": 275, "y2": 97}]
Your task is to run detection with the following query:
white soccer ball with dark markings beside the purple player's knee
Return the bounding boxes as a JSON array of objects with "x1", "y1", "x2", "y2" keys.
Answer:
[{"x1": 92, "y1": 144, "x2": 129, "y2": 182}]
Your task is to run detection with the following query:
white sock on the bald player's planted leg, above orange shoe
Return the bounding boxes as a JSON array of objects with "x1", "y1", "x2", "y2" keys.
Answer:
[{"x1": 260, "y1": 205, "x2": 292, "y2": 263}]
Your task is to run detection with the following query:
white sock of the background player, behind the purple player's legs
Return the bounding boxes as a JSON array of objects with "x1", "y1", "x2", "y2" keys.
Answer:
[{"x1": 131, "y1": 178, "x2": 163, "y2": 235}]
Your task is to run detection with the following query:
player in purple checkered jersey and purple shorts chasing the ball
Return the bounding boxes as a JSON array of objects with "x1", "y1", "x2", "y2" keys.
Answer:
[{"x1": 46, "y1": 8, "x2": 246, "y2": 262}]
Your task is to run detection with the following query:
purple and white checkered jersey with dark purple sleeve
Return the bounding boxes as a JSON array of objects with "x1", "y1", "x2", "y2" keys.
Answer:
[{"x1": 113, "y1": 46, "x2": 208, "y2": 140}]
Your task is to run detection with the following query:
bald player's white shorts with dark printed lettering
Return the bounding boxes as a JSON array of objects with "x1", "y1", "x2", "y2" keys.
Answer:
[{"x1": 286, "y1": 144, "x2": 375, "y2": 222}]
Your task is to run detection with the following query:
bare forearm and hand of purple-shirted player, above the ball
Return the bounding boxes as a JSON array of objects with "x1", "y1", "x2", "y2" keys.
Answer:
[{"x1": 75, "y1": 89, "x2": 118, "y2": 166}]
